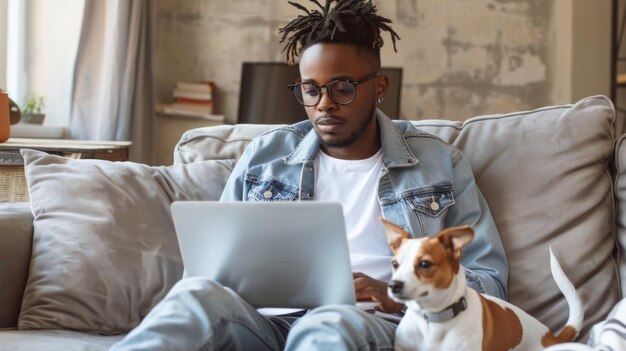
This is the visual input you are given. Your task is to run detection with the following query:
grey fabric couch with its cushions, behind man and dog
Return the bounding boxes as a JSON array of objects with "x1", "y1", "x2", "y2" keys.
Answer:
[{"x1": 0, "y1": 96, "x2": 626, "y2": 350}]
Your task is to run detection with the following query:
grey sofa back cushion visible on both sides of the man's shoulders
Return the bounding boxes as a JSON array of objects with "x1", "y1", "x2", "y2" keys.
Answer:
[{"x1": 175, "y1": 96, "x2": 620, "y2": 334}]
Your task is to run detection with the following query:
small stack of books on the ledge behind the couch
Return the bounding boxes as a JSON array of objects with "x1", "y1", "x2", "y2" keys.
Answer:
[{"x1": 161, "y1": 81, "x2": 224, "y2": 121}]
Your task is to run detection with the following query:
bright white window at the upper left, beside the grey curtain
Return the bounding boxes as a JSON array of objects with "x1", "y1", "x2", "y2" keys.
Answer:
[{"x1": 0, "y1": 0, "x2": 84, "y2": 126}]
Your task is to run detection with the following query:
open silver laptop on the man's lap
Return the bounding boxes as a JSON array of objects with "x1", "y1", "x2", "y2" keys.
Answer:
[{"x1": 172, "y1": 201, "x2": 355, "y2": 308}]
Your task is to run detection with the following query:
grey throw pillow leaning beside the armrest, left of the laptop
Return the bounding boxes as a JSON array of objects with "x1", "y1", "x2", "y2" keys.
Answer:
[{"x1": 18, "y1": 150, "x2": 225, "y2": 334}]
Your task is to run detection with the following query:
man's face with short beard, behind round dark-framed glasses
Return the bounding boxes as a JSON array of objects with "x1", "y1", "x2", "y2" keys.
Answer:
[{"x1": 300, "y1": 44, "x2": 387, "y2": 159}]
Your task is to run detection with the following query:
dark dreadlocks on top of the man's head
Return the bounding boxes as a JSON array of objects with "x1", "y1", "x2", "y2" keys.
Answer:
[{"x1": 279, "y1": 0, "x2": 400, "y2": 65}]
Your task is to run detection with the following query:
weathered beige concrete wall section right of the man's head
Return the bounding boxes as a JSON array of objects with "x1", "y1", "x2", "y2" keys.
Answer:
[{"x1": 385, "y1": 0, "x2": 553, "y2": 120}]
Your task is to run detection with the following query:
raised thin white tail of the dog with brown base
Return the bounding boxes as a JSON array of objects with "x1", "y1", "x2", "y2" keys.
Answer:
[{"x1": 550, "y1": 246, "x2": 585, "y2": 342}]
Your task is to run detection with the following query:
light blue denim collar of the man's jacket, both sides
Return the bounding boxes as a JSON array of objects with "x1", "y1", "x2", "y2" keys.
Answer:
[{"x1": 284, "y1": 110, "x2": 418, "y2": 167}]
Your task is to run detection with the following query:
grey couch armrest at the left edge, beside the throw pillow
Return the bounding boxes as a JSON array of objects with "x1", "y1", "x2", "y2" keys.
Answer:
[{"x1": 0, "y1": 202, "x2": 33, "y2": 328}]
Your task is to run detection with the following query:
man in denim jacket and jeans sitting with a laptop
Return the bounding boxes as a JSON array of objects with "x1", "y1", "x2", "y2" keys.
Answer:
[{"x1": 113, "y1": 0, "x2": 508, "y2": 350}]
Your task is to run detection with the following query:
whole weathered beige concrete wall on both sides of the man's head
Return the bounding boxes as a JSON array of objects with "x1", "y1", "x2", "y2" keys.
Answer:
[{"x1": 155, "y1": 0, "x2": 588, "y2": 122}]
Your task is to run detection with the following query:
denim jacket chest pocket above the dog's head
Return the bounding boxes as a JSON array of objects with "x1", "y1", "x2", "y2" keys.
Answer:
[{"x1": 402, "y1": 184, "x2": 455, "y2": 217}]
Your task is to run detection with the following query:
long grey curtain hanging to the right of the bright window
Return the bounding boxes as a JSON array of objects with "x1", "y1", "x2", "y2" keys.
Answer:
[{"x1": 70, "y1": 0, "x2": 155, "y2": 164}]
